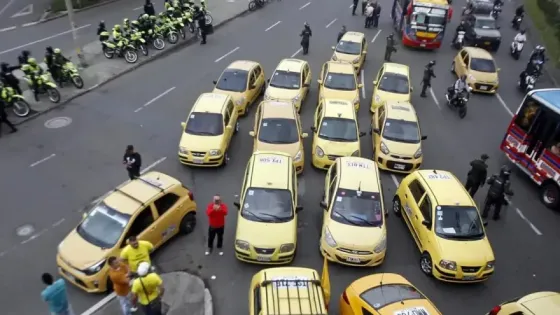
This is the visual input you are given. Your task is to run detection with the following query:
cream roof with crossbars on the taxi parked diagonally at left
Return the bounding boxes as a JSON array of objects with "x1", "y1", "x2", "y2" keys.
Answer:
[{"x1": 103, "y1": 172, "x2": 181, "y2": 215}]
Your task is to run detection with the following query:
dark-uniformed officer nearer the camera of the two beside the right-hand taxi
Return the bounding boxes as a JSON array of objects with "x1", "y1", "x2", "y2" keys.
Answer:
[{"x1": 482, "y1": 165, "x2": 513, "y2": 220}]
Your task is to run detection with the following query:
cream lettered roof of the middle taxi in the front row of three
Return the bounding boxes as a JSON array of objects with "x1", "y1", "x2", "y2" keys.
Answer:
[{"x1": 337, "y1": 156, "x2": 381, "y2": 192}]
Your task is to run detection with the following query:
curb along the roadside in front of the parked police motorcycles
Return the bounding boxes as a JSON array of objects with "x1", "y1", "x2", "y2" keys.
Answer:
[{"x1": 14, "y1": 7, "x2": 249, "y2": 126}]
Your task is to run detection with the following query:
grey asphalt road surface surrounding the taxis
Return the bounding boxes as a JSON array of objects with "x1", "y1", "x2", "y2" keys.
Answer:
[{"x1": 0, "y1": 0, "x2": 560, "y2": 315}]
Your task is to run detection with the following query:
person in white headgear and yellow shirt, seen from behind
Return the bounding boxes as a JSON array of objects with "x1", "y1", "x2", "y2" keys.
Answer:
[{"x1": 130, "y1": 262, "x2": 165, "y2": 315}]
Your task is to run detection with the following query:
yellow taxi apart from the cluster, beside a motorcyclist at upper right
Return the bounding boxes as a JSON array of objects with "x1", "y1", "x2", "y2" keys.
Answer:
[{"x1": 451, "y1": 47, "x2": 500, "y2": 94}]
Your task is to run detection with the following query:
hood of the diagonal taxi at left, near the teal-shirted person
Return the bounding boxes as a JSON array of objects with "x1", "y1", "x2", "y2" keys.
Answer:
[{"x1": 58, "y1": 230, "x2": 110, "y2": 270}]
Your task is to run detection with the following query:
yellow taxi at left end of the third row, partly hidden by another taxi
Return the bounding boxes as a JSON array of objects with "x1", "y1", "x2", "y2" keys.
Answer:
[{"x1": 212, "y1": 60, "x2": 266, "y2": 115}]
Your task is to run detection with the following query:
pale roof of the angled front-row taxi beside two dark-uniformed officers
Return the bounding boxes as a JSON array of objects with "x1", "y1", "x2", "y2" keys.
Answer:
[{"x1": 417, "y1": 170, "x2": 476, "y2": 207}]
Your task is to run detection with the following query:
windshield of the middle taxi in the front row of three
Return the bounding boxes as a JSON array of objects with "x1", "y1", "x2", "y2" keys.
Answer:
[{"x1": 331, "y1": 188, "x2": 383, "y2": 227}]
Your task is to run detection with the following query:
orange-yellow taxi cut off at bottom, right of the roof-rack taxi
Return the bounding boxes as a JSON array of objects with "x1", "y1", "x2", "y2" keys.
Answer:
[{"x1": 339, "y1": 273, "x2": 442, "y2": 315}]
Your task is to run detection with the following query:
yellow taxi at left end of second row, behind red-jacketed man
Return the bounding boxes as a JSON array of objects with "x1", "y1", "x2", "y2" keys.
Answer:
[{"x1": 179, "y1": 93, "x2": 239, "y2": 167}]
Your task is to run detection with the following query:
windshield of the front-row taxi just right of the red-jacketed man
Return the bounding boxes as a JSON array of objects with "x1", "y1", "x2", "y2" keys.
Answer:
[{"x1": 241, "y1": 187, "x2": 294, "y2": 223}]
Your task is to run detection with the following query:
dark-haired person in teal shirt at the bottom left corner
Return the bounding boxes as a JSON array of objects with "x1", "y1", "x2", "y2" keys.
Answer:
[{"x1": 41, "y1": 273, "x2": 74, "y2": 315}]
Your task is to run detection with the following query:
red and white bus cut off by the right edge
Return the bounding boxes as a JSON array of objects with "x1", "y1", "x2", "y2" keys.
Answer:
[{"x1": 500, "y1": 89, "x2": 560, "y2": 209}]
